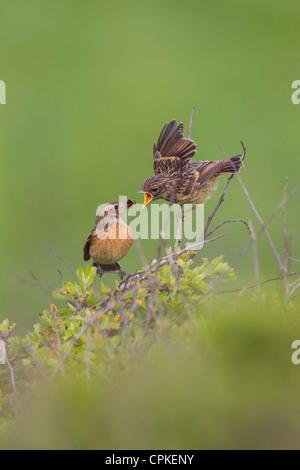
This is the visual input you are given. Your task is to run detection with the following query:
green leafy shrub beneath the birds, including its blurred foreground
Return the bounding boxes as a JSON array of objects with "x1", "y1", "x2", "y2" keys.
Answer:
[{"x1": 0, "y1": 253, "x2": 300, "y2": 449}]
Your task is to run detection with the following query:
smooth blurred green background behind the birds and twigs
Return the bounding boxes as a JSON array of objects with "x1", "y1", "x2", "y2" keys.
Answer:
[{"x1": 0, "y1": 0, "x2": 300, "y2": 332}]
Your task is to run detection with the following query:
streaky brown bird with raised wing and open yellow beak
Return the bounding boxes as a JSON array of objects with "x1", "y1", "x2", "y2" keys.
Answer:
[{"x1": 139, "y1": 120, "x2": 244, "y2": 206}]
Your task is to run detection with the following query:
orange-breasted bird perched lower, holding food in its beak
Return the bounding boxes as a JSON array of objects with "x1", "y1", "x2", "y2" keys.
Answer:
[{"x1": 83, "y1": 200, "x2": 135, "y2": 279}]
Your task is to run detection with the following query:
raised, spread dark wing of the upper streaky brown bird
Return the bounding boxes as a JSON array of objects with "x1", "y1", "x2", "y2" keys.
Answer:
[{"x1": 153, "y1": 120, "x2": 196, "y2": 175}]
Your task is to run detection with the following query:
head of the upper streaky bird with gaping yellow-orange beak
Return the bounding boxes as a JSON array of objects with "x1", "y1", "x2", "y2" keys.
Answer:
[{"x1": 138, "y1": 174, "x2": 175, "y2": 207}]
